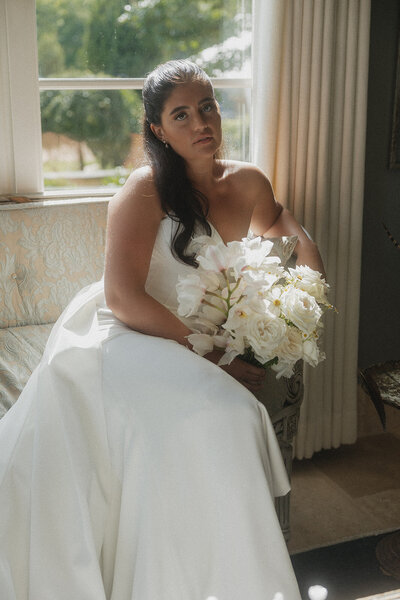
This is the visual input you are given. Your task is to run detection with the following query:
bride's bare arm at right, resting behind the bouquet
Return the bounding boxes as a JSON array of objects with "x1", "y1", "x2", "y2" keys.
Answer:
[{"x1": 251, "y1": 169, "x2": 326, "y2": 277}]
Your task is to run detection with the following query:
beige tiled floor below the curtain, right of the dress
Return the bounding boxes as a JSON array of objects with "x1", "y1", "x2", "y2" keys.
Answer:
[{"x1": 288, "y1": 386, "x2": 400, "y2": 556}]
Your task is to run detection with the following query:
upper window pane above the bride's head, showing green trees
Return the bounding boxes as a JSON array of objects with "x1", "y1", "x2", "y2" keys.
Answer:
[{"x1": 36, "y1": 0, "x2": 252, "y2": 77}]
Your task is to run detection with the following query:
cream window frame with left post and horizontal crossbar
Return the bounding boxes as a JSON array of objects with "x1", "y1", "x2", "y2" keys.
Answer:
[{"x1": 0, "y1": 0, "x2": 252, "y2": 197}]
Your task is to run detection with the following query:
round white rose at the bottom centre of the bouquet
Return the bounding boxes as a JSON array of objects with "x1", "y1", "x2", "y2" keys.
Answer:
[{"x1": 246, "y1": 312, "x2": 287, "y2": 363}]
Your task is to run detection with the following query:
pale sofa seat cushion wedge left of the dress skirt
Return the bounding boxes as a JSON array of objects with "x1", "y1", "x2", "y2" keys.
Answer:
[{"x1": 0, "y1": 323, "x2": 53, "y2": 418}]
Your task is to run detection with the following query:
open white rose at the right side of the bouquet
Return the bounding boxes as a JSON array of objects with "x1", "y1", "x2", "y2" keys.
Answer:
[{"x1": 280, "y1": 287, "x2": 322, "y2": 335}]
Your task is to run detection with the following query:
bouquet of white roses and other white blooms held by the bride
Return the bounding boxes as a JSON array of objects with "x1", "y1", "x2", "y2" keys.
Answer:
[{"x1": 177, "y1": 236, "x2": 333, "y2": 378}]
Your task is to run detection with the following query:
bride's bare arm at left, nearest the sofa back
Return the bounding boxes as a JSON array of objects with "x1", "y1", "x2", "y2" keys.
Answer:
[{"x1": 104, "y1": 168, "x2": 192, "y2": 345}]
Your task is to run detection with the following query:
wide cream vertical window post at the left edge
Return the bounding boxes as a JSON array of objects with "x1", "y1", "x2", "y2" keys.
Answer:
[{"x1": 0, "y1": 0, "x2": 43, "y2": 194}]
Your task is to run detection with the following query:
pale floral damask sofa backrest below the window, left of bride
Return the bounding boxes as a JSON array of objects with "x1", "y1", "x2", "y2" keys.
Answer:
[{"x1": 0, "y1": 200, "x2": 107, "y2": 327}]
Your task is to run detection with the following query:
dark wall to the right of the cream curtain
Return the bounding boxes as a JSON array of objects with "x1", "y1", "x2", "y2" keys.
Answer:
[{"x1": 359, "y1": 0, "x2": 400, "y2": 367}]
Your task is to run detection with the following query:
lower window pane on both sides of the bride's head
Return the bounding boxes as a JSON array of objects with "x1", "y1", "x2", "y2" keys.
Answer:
[{"x1": 41, "y1": 89, "x2": 250, "y2": 189}]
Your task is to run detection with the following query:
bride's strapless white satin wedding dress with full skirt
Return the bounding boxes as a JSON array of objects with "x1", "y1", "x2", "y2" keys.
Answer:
[{"x1": 0, "y1": 218, "x2": 300, "y2": 600}]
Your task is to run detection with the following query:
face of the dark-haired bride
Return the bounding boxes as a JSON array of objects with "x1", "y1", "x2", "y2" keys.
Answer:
[{"x1": 151, "y1": 81, "x2": 222, "y2": 162}]
